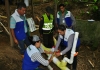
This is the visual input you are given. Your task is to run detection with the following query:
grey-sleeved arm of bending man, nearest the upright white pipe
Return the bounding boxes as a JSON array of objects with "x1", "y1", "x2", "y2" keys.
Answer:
[{"x1": 60, "y1": 34, "x2": 74, "y2": 55}]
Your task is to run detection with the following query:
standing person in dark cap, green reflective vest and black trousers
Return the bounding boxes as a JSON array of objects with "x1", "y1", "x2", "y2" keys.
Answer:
[{"x1": 39, "y1": 6, "x2": 55, "y2": 48}]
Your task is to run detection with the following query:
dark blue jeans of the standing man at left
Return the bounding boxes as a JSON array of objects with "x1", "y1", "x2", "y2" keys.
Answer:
[{"x1": 18, "y1": 37, "x2": 31, "y2": 55}]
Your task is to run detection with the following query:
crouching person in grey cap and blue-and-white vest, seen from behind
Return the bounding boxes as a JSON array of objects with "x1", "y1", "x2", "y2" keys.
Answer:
[{"x1": 22, "y1": 35, "x2": 53, "y2": 70}]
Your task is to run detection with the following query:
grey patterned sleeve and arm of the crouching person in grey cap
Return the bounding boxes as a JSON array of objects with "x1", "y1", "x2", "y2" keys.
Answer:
[{"x1": 31, "y1": 52, "x2": 51, "y2": 66}]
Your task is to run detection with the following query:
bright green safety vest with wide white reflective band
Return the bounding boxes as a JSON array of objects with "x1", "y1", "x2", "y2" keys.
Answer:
[{"x1": 42, "y1": 14, "x2": 53, "y2": 33}]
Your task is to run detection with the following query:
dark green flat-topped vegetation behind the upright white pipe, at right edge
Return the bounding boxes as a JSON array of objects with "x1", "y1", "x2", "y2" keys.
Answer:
[{"x1": 76, "y1": 20, "x2": 100, "y2": 50}]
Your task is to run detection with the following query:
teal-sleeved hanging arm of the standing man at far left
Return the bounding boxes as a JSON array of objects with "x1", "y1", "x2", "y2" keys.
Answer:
[{"x1": 10, "y1": 17, "x2": 18, "y2": 44}]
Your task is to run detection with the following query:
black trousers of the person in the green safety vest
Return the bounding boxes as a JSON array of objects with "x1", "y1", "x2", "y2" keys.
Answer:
[{"x1": 43, "y1": 32, "x2": 54, "y2": 48}]
